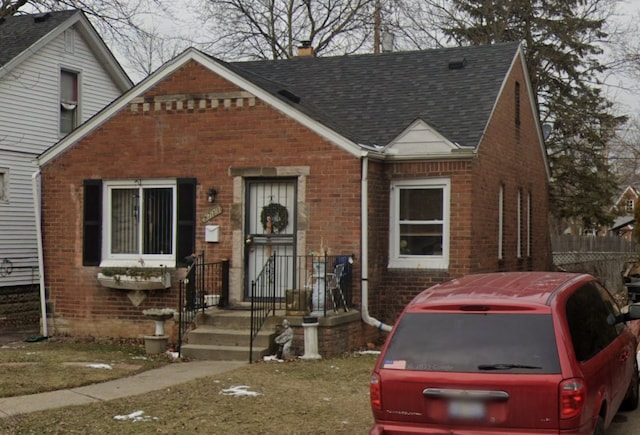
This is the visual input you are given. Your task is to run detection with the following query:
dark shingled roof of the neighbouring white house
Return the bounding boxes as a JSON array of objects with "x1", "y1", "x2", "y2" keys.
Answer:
[{"x1": 0, "y1": 10, "x2": 80, "y2": 68}]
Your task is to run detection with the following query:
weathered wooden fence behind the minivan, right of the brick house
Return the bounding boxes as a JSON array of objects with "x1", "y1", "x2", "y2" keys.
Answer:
[{"x1": 551, "y1": 235, "x2": 640, "y2": 295}]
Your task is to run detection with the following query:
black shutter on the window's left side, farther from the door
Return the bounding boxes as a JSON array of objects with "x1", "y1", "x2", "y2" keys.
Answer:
[{"x1": 82, "y1": 180, "x2": 102, "y2": 266}]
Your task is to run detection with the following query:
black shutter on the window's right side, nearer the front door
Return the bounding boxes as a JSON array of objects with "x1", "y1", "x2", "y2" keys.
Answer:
[{"x1": 176, "y1": 178, "x2": 197, "y2": 266}]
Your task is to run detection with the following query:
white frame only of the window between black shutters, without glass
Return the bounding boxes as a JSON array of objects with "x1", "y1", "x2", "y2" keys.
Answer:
[{"x1": 100, "y1": 179, "x2": 178, "y2": 267}]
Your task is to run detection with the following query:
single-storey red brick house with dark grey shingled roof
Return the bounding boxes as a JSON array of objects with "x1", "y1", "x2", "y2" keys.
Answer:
[{"x1": 39, "y1": 43, "x2": 551, "y2": 353}]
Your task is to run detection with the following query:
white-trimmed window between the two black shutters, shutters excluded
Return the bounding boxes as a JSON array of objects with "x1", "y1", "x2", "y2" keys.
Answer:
[{"x1": 101, "y1": 180, "x2": 177, "y2": 266}]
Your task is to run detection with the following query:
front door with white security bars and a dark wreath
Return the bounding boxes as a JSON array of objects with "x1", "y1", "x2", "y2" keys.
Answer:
[{"x1": 245, "y1": 179, "x2": 297, "y2": 300}]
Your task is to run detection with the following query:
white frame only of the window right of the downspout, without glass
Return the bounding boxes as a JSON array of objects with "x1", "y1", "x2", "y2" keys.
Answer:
[{"x1": 389, "y1": 178, "x2": 451, "y2": 270}]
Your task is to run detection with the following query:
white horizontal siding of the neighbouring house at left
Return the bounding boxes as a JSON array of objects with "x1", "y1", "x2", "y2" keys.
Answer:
[{"x1": 0, "y1": 24, "x2": 127, "y2": 287}]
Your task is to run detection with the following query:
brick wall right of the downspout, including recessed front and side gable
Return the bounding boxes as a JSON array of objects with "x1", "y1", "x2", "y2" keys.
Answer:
[{"x1": 369, "y1": 55, "x2": 551, "y2": 324}]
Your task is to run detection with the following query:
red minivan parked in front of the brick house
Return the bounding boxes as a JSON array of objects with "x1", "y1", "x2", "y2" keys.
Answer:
[{"x1": 370, "y1": 272, "x2": 640, "y2": 435}]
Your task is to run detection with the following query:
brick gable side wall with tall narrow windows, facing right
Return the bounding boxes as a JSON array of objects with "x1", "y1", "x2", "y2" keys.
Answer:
[{"x1": 470, "y1": 57, "x2": 551, "y2": 272}]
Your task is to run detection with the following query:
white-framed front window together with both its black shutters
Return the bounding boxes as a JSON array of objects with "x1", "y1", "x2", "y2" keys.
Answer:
[{"x1": 83, "y1": 178, "x2": 196, "y2": 267}]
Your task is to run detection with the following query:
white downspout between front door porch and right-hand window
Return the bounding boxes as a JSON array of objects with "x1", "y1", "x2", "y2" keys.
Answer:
[{"x1": 360, "y1": 155, "x2": 391, "y2": 332}]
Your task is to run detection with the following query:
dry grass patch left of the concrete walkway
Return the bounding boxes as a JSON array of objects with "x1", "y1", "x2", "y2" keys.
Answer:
[{"x1": 0, "y1": 339, "x2": 170, "y2": 397}]
